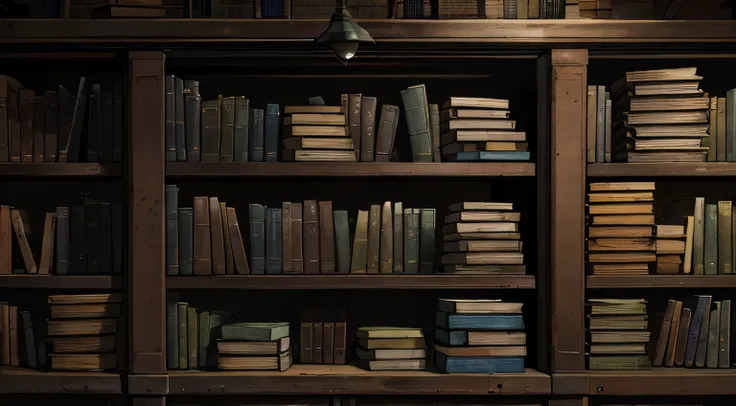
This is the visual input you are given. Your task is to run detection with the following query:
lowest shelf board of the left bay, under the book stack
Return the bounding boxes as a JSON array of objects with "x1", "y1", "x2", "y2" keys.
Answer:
[{"x1": 0, "y1": 367, "x2": 122, "y2": 394}]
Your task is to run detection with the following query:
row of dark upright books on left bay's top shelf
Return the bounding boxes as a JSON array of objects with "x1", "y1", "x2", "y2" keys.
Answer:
[{"x1": 0, "y1": 75, "x2": 124, "y2": 163}]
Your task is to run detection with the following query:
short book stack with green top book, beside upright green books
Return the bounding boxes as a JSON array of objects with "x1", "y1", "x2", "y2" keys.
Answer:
[{"x1": 217, "y1": 323, "x2": 291, "y2": 372}]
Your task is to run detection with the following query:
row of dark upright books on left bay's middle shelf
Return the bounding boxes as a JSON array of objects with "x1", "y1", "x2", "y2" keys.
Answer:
[{"x1": 0, "y1": 201, "x2": 123, "y2": 275}]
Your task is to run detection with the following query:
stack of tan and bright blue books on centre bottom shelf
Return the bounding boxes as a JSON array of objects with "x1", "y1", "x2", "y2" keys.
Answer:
[{"x1": 434, "y1": 299, "x2": 526, "y2": 373}]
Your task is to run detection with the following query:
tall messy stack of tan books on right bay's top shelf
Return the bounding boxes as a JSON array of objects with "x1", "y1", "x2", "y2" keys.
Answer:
[{"x1": 611, "y1": 68, "x2": 708, "y2": 162}]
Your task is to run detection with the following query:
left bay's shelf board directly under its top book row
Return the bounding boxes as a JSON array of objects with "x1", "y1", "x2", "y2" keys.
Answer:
[{"x1": 0, "y1": 163, "x2": 122, "y2": 178}]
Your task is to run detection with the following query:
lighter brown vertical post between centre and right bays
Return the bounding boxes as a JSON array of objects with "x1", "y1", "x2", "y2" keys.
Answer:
[{"x1": 550, "y1": 49, "x2": 588, "y2": 372}]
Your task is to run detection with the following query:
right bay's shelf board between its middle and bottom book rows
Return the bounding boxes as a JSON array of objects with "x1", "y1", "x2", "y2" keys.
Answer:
[{"x1": 586, "y1": 275, "x2": 736, "y2": 289}]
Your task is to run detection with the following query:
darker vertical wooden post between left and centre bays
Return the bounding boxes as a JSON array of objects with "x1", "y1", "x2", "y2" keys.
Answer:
[{"x1": 128, "y1": 52, "x2": 166, "y2": 376}]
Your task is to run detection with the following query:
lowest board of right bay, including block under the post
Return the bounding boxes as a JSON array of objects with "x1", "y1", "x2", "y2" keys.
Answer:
[{"x1": 552, "y1": 368, "x2": 736, "y2": 396}]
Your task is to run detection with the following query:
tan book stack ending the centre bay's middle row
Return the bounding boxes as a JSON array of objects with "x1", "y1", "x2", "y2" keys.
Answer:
[{"x1": 442, "y1": 202, "x2": 526, "y2": 274}]
